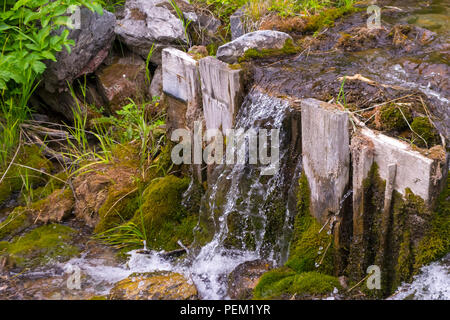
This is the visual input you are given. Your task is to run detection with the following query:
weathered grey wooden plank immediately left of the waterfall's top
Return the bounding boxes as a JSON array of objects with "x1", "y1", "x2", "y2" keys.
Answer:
[{"x1": 200, "y1": 57, "x2": 243, "y2": 132}]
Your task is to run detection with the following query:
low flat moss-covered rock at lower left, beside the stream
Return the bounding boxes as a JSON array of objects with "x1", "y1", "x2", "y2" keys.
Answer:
[{"x1": 3, "y1": 224, "x2": 80, "y2": 269}]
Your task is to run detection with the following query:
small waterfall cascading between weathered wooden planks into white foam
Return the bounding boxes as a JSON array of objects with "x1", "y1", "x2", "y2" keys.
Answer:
[{"x1": 183, "y1": 89, "x2": 301, "y2": 299}]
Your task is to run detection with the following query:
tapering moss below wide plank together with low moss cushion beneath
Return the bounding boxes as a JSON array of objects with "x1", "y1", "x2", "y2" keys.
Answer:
[{"x1": 254, "y1": 173, "x2": 340, "y2": 299}]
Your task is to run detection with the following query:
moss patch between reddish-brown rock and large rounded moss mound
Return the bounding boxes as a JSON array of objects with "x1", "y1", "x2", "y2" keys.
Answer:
[{"x1": 94, "y1": 185, "x2": 139, "y2": 233}]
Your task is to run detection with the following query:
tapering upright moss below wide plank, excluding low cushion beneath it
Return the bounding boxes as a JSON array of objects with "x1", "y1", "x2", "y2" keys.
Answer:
[{"x1": 286, "y1": 174, "x2": 334, "y2": 273}]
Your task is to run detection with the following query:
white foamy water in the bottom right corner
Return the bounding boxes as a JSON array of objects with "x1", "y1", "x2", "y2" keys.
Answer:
[{"x1": 388, "y1": 254, "x2": 450, "y2": 300}]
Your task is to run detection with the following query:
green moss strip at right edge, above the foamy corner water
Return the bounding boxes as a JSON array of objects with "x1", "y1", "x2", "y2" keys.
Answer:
[{"x1": 414, "y1": 173, "x2": 450, "y2": 271}]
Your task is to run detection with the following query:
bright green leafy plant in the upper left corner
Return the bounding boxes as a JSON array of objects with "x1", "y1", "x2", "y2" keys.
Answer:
[{"x1": 0, "y1": 0, "x2": 102, "y2": 166}]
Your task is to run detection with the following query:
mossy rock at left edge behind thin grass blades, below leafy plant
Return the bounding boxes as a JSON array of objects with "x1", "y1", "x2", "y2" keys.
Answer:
[{"x1": 0, "y1": 145, "x2": 53, "y2": 203}]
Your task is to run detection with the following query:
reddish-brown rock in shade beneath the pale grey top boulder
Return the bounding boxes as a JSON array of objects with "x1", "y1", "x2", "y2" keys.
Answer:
[{"x1": 95, "y1": 54, "x2": 148, "y2": 111}]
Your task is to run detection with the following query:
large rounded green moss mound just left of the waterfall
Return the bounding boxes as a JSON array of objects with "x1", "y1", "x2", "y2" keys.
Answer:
[{"x1": 131, "y1": 175, "x2": 198, "y2": 251}]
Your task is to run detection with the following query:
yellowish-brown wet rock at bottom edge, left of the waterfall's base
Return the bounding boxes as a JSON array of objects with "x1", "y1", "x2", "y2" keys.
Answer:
[{"x1": 108, "y1": 271, "x2": 198, "y2": 300}]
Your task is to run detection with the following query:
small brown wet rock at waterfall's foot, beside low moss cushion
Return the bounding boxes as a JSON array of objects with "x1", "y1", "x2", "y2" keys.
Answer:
[{"x1": 228, "y1": 260, "x2": 273, "y2": 300}]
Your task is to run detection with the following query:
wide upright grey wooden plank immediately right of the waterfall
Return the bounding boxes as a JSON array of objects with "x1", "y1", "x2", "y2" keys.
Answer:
[{"x1": 301, "y1": 99, "x2": 350, "y2": 223}]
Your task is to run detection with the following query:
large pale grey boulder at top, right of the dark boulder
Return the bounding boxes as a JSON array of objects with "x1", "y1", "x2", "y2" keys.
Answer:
[{"x1": 115, "y1": 0, "x2": 187, "y2": 65}]
